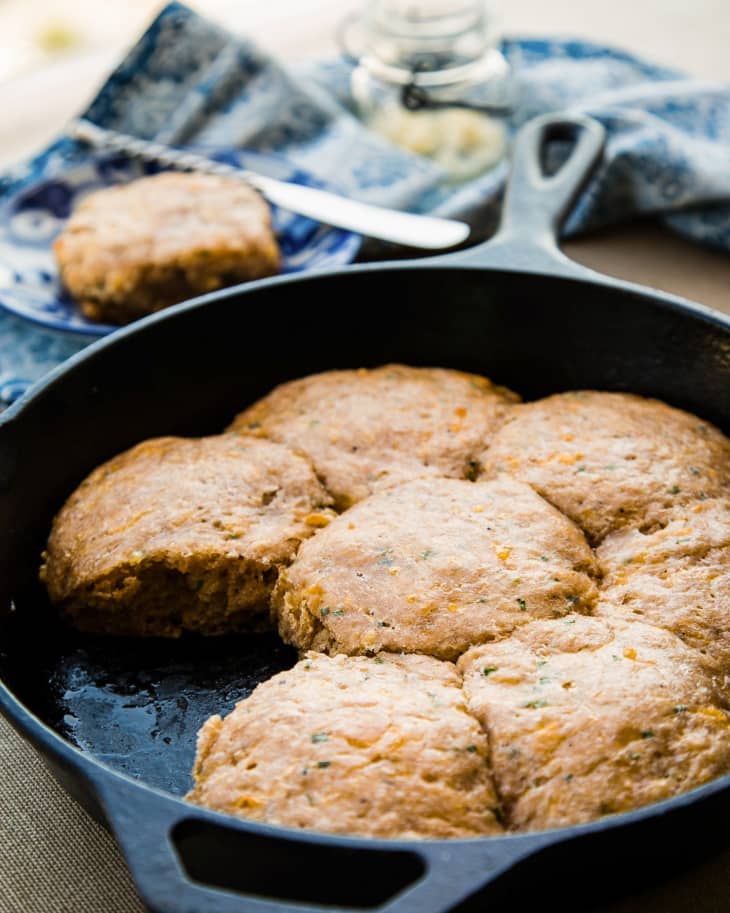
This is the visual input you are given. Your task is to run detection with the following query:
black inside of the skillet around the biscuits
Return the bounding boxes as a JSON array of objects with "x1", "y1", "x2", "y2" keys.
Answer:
[{"x1": 0, "y1": 266, "x2": 730, "y2": 794}]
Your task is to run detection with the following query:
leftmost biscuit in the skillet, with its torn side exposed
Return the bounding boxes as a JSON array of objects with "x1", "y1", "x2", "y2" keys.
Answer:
[{"x1": 41, "y1": 435, "x2": 331, "y2": 637}]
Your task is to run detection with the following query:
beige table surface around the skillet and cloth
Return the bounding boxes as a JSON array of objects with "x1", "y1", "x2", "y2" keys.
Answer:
[{"x1": 0, "y1": 0, "x2": 730, "y2": 913}]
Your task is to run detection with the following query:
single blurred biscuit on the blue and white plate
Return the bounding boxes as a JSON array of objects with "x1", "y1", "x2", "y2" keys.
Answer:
[{"x1": 53, "y1": 171, "x2": 279, "y2": 323}]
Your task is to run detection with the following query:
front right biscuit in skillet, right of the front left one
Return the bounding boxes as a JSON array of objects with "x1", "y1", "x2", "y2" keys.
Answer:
[{"x1": 458, "y1": 615, "x2": 730, "y2": 830}]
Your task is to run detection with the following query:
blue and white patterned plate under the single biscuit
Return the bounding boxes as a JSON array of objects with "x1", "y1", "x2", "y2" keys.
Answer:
[{"x1": 0, "y1": 149, "x2": 361, "y2": 336}]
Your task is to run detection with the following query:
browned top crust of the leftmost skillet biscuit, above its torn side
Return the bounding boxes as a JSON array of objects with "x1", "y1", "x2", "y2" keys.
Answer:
[{"x1": 45, "y1": 435, "x2": 331, "y2": 600}]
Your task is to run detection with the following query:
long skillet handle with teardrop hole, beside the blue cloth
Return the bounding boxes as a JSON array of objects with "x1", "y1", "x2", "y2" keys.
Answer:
[{"x1": 441, "y1": 114, "x2": 606, "y2": 277}]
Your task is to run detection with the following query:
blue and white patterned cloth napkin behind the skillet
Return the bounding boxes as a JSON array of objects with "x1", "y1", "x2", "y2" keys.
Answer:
[{"x1": 0, "y1": 3, "x2": 730, "y2": 403}]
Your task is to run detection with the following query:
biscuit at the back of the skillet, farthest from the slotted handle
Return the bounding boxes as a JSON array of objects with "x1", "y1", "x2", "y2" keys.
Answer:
[{"x1": 232, "y1": 365, "x2": 519, "y2": 509}]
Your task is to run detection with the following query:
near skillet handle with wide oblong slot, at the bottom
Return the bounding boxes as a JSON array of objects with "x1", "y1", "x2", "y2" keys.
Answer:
[{"x1": 90, "y1": 771, "x2": 555, "y2": 913}]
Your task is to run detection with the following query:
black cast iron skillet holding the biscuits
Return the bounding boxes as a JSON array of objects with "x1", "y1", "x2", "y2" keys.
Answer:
[{"x1": 0, "y1": 117, "x2": 730, "y2": 913}]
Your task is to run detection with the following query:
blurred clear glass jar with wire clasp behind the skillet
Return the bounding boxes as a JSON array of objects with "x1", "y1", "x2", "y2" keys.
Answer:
[{"x1": 345, "y1": 0, "x2": 510, "y2": 180}]
